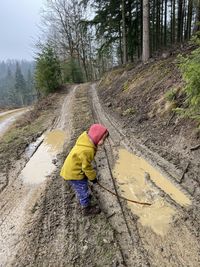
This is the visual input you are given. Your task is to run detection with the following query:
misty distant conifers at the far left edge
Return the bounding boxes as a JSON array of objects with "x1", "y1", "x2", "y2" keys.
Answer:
[{"x1": 0, "y1": 60, "x2": 37, "y2": 107}]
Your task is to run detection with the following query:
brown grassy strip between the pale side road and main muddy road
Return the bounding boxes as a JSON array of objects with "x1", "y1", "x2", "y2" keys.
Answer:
[{"x1": 0, "y1": 94, "x2": 58, "y2": 166}]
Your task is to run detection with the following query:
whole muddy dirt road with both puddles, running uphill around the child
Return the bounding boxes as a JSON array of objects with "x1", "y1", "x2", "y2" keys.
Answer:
[{"x1": 0, "y1": 84, "x2": 200, "y2": 267}]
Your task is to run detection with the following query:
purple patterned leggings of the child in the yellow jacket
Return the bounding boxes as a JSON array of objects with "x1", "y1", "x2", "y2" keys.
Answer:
[{"x1": 68, "y1": 178, "x2": 90, "y2": 207}]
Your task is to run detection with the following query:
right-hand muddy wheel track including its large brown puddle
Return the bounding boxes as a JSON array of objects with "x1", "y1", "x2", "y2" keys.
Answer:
[{"x1": 91, "y1": 86, "x2": 200, "y2": 267}]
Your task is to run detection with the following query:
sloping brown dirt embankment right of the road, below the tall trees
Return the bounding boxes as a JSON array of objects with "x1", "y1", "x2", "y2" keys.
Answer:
[{"x1": 97, "y1": 56, "x2": 200, "y2": 202}]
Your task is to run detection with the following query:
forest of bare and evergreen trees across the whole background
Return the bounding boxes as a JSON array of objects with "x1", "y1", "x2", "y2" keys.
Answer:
[{"x1": 0, "y1": 0, "x2": 200, "y2": 106}]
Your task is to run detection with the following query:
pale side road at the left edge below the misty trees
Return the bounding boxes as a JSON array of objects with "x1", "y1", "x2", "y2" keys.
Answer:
[{"x1": 0, "y1": 108, "x2": 28, "y2": 137}]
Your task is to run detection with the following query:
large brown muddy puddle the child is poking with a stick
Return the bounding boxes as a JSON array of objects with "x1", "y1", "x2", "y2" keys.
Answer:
[{"x1": 113, "y1": 149, "x2": 191, "y2": 236}]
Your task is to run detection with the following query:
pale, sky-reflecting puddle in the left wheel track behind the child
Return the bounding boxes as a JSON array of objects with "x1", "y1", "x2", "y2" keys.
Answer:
[{"x1": 20, "y1": 130, "x2": 67, "y2": 185}]
